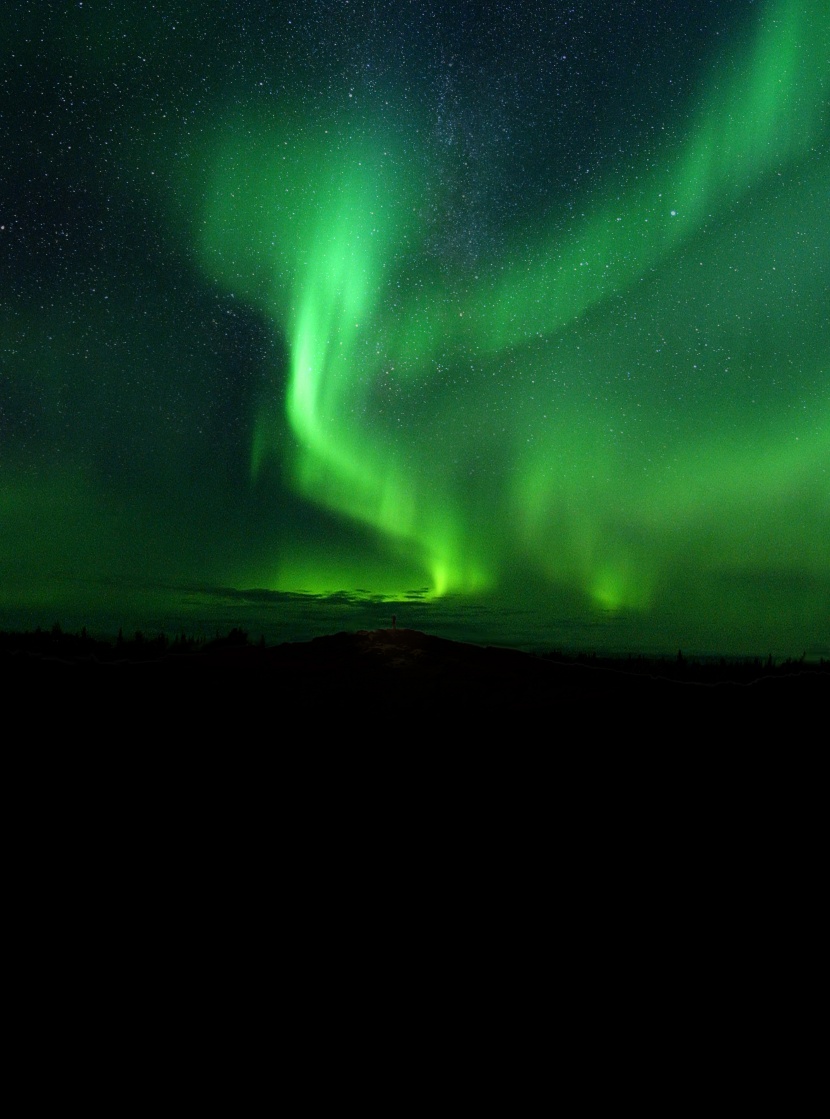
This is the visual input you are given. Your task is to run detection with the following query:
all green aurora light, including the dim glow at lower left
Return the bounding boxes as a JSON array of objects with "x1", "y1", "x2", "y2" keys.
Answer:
[{"x1": 0, "y1": 0, "x2": 830, "y2": 652}]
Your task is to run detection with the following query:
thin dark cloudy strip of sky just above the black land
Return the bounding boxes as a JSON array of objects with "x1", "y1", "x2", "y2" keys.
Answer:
[{"x1": 0, "y1": 585, "x2": 830, "y2": 662}]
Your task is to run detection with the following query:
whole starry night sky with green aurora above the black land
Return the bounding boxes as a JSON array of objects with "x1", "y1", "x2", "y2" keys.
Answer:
[{"x1": 0, "y1": 0, "x2": 830, "y2": 656}]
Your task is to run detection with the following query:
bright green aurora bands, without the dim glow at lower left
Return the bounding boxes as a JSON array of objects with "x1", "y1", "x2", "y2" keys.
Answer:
[{"x1": 189, "y1": 0, "x2": 830, "y2": 611}]
